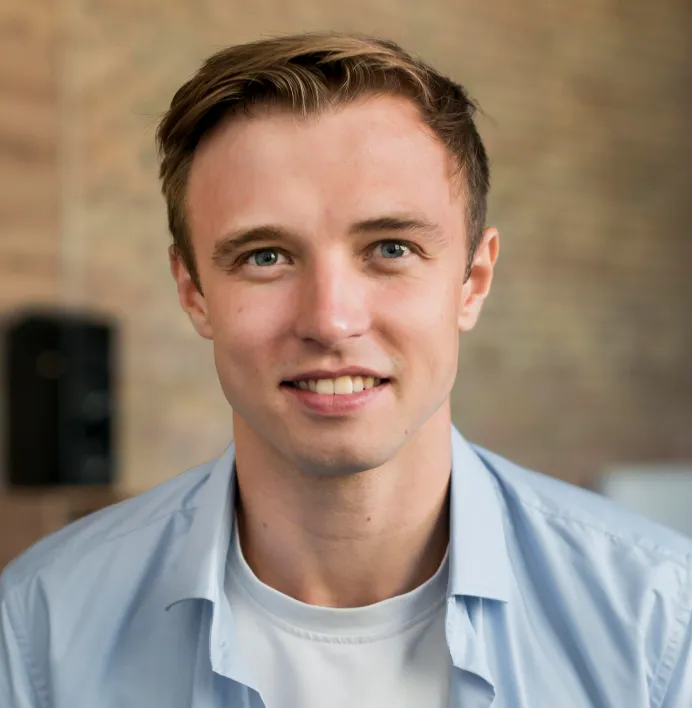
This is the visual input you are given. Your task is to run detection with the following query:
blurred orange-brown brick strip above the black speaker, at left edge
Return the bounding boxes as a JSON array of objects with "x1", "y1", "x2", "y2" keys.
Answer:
[{"x1": 0, "y1": 0, "x2": 60, "y2": 311}]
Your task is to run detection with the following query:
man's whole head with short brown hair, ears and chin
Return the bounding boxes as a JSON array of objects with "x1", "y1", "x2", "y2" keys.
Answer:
[{"x1": 157, "y1": 33, "x2": 498, "y2": 474}]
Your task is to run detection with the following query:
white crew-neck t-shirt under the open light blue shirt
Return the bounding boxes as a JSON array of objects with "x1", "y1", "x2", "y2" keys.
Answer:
[{"x1": 226, "y1": 528, "x2": 452, "y2": 708}]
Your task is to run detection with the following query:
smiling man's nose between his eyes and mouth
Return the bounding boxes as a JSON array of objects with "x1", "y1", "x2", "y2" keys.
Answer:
[{"x1": 295, "y1": 259, "x2": 371, "y2": 348}]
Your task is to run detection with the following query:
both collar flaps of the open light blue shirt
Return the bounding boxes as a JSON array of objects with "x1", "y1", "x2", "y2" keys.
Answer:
[{"x1": 165, "y1": 426, "x2": 509, "y2": 609}]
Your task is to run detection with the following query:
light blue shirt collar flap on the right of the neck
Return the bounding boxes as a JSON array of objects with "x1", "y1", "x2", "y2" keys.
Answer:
[{"x1": 448, "y1": 426, "x2": 510, "y2": 602}]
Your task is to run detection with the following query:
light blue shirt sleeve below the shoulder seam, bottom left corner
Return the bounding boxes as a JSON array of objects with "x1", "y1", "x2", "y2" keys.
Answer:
[{"x1": 0, "y1": 578, "x2": 45, "y2": 708}]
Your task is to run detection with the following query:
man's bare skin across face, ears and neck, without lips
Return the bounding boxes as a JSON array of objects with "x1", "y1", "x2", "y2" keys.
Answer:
[{"x1": 170, "y1": 91, "x2": 499, "y2": 607}]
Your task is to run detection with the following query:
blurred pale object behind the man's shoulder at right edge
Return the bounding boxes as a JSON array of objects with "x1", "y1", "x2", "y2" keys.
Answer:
[{"x1": 596, "y1": 462, "x2": 692, "y2": 537}]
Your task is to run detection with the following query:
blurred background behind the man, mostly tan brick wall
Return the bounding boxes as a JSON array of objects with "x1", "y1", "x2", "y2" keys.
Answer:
[{"x1": 0, "y1": 0, "x2": 692, "y2": 565}]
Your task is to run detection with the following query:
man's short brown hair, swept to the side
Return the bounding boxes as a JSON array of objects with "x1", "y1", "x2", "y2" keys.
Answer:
[{"x1": 156, "y1": 32, "x2": 490, "y2": 292}]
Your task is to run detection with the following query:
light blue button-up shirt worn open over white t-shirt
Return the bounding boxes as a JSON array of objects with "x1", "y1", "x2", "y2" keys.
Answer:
[{"x1": 0, "y1": 430, "x2": 692, "y2": 708}]
